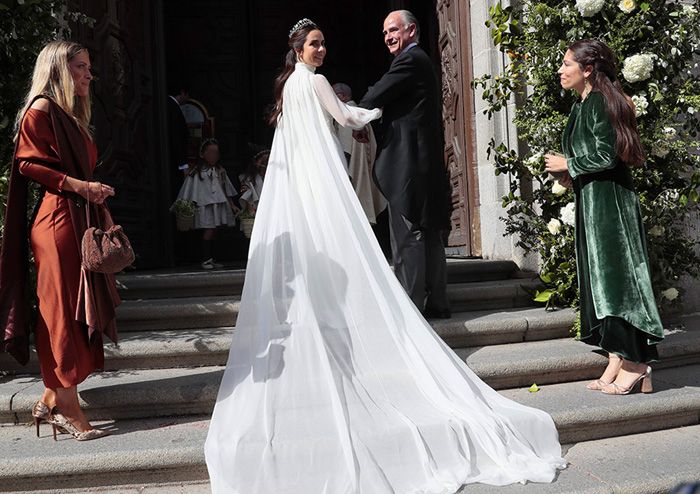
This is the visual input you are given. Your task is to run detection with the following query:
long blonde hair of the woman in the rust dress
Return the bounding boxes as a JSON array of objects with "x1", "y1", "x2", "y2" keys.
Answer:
[{"x1": 15, "y1": 40, "x2": 92, "y2": 135}]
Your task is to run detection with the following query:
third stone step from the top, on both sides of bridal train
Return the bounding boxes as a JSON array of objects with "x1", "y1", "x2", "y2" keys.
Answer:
[{"x1": 0, "y1": 308, "x2": 574, "y2": 374}]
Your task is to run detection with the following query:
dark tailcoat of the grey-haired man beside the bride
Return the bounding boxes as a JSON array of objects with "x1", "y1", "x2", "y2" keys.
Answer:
[{"x1": 360, "y1": 46, "x2": 451, "y2": 229}]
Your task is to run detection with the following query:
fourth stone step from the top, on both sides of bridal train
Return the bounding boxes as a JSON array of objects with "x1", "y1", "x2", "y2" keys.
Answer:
[{"x1": 0, "y1": 331, "x2": 700, "y2": 424}]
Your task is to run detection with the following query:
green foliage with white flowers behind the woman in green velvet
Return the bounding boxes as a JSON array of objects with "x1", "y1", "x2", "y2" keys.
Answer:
[{"x1": 474, "y1": 0, "x2": 700, "y2": 309}]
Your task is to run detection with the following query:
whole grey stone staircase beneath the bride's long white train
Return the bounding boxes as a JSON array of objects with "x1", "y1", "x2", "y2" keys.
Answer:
[{"x1": 0, "y1": 260, "x2": 700, "y2": 494}]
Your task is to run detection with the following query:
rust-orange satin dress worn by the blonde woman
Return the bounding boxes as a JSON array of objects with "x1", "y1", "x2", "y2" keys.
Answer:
[{"x1": 17, "y1": 108, "x2": 104, "y2": 389}]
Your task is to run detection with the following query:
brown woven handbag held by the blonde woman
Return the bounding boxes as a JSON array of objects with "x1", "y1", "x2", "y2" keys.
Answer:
[{"x1": 81, "y1": 186, "x2": 135, "y2": 273}]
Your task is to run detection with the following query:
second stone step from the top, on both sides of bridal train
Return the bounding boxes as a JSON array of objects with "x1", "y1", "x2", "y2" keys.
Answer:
[{"x1": 117, "y1": 278, "x2": 539, "y2": 332}]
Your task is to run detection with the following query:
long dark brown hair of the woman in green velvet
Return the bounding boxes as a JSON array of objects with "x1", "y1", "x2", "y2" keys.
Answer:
[{"x1": 569, "y1": 39, "x2": 645, "y2": 166}]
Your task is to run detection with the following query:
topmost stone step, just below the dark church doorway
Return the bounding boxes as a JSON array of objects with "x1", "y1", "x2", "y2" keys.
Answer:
[{"x1": 117, "y1": 259, "x2": 524, "y2": 300}]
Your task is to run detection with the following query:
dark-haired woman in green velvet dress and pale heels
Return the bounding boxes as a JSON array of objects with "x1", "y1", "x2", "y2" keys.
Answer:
[{"x1": 545, "y1": 40, "x2": 663, "y2": 394}]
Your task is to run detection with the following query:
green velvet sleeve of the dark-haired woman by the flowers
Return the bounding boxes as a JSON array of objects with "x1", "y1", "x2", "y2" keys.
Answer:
[{"x1": 566, "y1": 92, "x2": 617, "y2": 178}]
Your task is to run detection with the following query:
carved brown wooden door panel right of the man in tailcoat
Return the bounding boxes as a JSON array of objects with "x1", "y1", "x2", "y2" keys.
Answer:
[{"x1": 436, "y1": 0, "x2": 480, "y2": 255}]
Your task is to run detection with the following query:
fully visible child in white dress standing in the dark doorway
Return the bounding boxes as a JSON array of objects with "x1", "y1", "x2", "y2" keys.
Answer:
[{"x1": 177, "y1": 139, "x2": 238, "y2": 269}]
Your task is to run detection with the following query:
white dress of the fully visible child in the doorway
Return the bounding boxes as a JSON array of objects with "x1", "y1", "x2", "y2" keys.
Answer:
[{"x1": 177, "y1": 165, "x2": 238, "y2": 229}]
